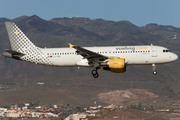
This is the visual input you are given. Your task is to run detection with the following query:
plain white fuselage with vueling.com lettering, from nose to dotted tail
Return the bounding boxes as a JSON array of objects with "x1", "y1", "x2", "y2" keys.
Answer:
[{"x1": 37, "y1": 46, "x2": 178, "y2": 67}]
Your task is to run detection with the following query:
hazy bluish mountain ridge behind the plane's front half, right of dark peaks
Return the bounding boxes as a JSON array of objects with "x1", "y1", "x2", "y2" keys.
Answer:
[{"x1": 50, "y1": 17, "x2": 180, "y2": 50}]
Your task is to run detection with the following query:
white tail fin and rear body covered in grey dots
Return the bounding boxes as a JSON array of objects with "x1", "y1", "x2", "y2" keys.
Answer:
[{"x1": 5, "y1": 22, "x2": 52, "y2": 65}]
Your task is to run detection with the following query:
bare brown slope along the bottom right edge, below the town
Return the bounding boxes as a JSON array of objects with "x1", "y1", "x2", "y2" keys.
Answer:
[{"x1": 93, "y1": 108, "x2": 180, "y2": 120}]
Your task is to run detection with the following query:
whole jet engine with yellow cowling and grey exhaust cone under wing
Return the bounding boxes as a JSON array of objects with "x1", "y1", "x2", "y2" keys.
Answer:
[{"x1": 101, "y1": 58, "x2": 126, "y2": 73}]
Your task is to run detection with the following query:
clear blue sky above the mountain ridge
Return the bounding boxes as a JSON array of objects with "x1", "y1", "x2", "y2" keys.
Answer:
[{"x1": 0, "y1": 0, "x2": 180, "y2": 28}]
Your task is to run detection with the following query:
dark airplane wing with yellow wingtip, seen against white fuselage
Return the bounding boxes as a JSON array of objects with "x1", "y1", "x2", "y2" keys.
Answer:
[{"x1": 69, "y1": 43, "x2": 108, "y2": 62}]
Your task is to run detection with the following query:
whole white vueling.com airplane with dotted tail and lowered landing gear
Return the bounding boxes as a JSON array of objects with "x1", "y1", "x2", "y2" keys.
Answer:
[{"x1": 2, "y1": 22, "x2": 178, "y2": 78}]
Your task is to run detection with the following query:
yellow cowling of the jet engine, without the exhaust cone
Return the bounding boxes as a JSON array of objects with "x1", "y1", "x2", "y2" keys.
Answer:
[{"x1": 108, "y1": 58, "x2": 126, "y2": 73}]
